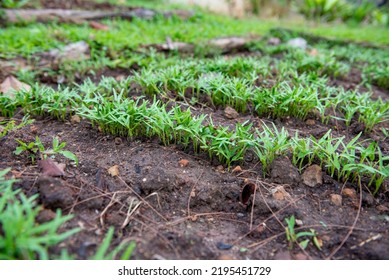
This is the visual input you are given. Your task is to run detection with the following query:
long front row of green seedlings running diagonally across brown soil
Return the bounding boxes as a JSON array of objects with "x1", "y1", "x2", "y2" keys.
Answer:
[{"x1": 1, "y1": 82, "x2": 389, "y2": 190}]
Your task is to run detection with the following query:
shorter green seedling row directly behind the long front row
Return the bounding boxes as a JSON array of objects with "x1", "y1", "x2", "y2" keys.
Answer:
[{"x1": 129, "y1": 59, "x2": 389, "y2": 131}]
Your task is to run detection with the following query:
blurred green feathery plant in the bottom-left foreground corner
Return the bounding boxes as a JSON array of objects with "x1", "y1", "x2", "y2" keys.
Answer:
[{"x1": 0, "y1": 169, "x2": 80, "y2": 260}]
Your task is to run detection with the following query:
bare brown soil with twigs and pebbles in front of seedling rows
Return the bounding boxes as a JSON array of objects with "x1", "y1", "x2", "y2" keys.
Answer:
[{"x1": 0, "y1": 0, "x2": 389, "y2": 259}]
